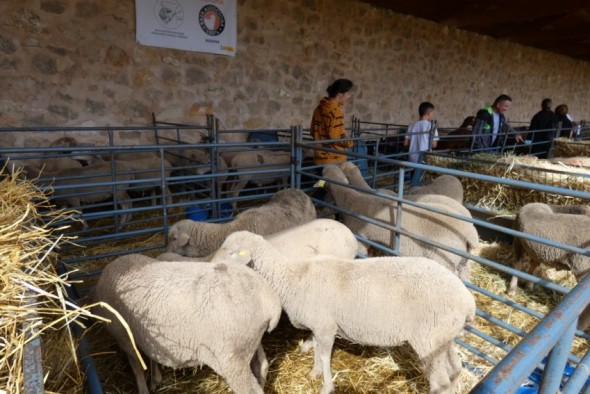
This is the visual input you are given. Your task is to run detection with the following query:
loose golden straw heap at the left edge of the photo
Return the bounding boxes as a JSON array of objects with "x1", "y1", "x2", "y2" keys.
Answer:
[{"x1": 0, "y1": 165, "x2": 101, "y2": 393}]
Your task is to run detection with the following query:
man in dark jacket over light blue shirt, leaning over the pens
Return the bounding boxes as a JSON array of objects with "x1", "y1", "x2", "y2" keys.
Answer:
[{"x1": 472, "y1": 94, "x2": 524, "y2": 151}]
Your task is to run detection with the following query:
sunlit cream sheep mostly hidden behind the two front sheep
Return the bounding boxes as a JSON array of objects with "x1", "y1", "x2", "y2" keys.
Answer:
[{"x1": 157, "y1": 219, "x2": 358, "y2": 262}]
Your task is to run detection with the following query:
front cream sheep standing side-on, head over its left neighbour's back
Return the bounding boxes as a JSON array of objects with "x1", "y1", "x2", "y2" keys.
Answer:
[{"x1": 214, "y1": 231, "x2": 475, "y2": 394}]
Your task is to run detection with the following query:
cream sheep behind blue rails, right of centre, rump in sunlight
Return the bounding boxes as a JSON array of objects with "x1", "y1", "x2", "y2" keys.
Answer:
[{"x1": 323, "y1": 165, "x2": 479, "y2": 281}]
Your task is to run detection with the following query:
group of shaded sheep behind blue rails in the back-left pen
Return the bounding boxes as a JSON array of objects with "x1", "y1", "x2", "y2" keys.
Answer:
[{"x1": 2, "y1": 136, "x2": 291, "y2": 231}]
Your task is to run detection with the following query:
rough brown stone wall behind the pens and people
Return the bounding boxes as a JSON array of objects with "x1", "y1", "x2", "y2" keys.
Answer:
[{"x1": 0, "y1": 0, "x2": 590, "y2": 143}]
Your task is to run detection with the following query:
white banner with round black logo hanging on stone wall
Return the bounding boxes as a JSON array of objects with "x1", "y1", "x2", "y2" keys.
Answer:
[{"x1": 135, "y1": 0, "x2": 238, "y2": 56}]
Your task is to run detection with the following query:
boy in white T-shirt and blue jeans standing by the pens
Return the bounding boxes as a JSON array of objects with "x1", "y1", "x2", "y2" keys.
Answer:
[{"x1": 404, "y1": 101, "x2": 439, "y2": 163}]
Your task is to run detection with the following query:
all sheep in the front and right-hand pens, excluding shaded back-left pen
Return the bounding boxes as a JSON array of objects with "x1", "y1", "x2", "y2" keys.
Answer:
[{"x1": 76, "y1": 151, "x2": 590, "y2": 394}]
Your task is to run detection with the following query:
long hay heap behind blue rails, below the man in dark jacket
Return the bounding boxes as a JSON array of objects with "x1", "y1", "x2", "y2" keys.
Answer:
[{"x1": 427, "y1": 154, "x2": 590, "y2": 214}]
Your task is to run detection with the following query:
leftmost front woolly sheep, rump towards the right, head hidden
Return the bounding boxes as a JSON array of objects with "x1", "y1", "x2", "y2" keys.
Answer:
[{"x1": 91, "y1": 254, "x2": 281, "y2": 394}]
